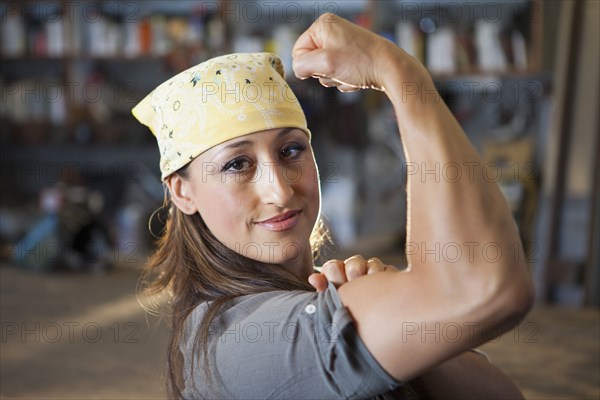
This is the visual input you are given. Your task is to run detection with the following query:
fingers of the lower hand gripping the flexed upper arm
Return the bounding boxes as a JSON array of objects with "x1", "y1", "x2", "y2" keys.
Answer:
[{"x1": 308, "y1": 254, "x2": 398, "y2": 292}]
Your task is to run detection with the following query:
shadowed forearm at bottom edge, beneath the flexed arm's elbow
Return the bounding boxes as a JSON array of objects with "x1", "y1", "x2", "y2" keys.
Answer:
[{"x1": 411, "y1": 352, "x2": 523, "y2": 400}]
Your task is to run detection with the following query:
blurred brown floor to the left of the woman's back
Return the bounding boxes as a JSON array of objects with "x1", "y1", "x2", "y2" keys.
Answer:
[{"x1": 0, "y1": 267, "x2": 167, "y2": 399}]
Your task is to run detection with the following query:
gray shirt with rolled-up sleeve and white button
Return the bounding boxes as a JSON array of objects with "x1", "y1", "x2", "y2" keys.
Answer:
[{"x1": 180, "y1": 284, "x2": 416, "y2": 399}]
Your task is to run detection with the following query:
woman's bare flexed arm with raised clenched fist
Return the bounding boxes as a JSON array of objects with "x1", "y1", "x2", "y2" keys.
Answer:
[{"x1": 293, "y1": 14, "x2": 533, "y2": 380}]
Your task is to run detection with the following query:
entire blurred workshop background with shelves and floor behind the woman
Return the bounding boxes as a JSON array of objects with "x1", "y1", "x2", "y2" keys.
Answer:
[{"x1": 0, "y1": 0, "x2": 600, "y2": 399}]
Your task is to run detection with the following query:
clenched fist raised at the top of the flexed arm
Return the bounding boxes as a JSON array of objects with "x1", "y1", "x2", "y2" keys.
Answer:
[{"x1": 292, "y1": 13, "x2": 412, "y2": 92}]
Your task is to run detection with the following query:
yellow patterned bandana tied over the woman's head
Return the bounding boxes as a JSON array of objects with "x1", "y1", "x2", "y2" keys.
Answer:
[{"x1": 132, "y1": 53, "x2": 310, "y2": 180}]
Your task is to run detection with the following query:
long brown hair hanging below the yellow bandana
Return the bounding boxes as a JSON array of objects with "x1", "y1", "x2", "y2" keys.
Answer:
[{"x1": 138, "y1": 164, "x2": 332, "y2": 399}]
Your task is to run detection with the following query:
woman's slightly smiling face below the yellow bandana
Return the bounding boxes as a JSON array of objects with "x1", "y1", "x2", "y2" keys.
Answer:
[{"x1": 178, "y1": 128, "x2": 320, "y2": 266}]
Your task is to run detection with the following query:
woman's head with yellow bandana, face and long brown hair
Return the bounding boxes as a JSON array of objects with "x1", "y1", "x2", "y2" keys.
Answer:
[{"x1": 133, "y1": 53, "x2": 342, "y2": 397}]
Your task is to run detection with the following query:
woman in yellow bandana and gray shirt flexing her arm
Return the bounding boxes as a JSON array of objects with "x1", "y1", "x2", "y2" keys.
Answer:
[{"x1": 133, "y1": 14, "x2": 532, "y2": 398}]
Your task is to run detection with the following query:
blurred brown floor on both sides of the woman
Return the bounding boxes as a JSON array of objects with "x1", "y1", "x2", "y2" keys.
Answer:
[{"x1": 0, "y1": 260, "x2": 600, "y2": 400}]
